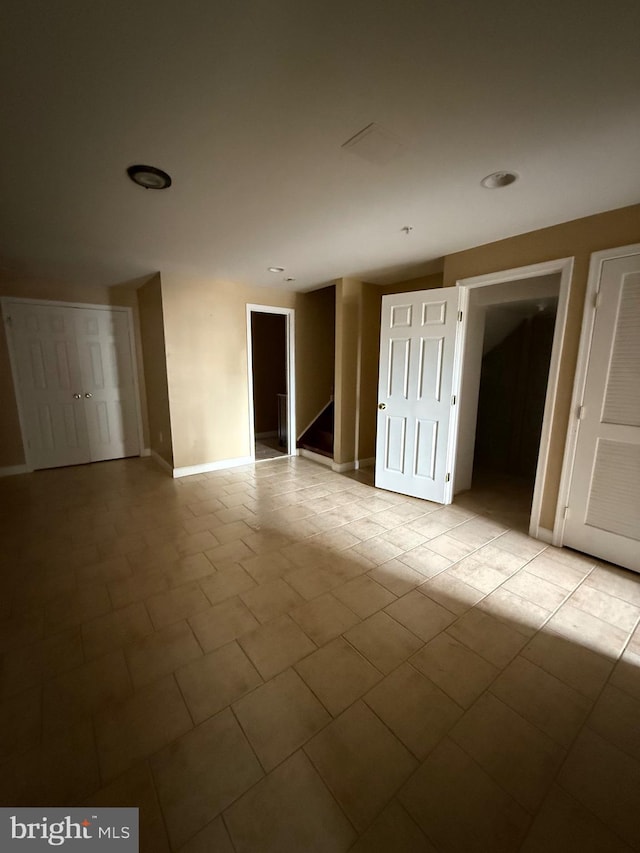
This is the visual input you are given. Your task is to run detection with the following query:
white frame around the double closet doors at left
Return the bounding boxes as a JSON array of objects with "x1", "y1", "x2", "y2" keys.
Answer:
[{"x1": 0, "y1": 296, "x2": 148, "y2": 474}]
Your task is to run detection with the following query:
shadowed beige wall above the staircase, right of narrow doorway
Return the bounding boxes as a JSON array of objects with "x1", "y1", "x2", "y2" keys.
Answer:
[{"x1": 296, "y1": 285, "x2": 336, "y2": 437}]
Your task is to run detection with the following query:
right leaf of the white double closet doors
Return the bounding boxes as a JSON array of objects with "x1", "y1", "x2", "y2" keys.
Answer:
[{"x1": 72, "y1": 308, "x2": 140, "y2": 462}]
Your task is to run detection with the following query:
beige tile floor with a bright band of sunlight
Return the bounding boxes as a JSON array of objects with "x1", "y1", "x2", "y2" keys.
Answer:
[{"x1": 0, "y1": 458, "x2": 640, "y2": 853}]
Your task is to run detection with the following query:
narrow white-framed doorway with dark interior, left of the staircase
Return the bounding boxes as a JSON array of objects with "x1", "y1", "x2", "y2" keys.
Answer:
[{"x1": 247, "y1": 305, "x2": 295, "y2": 461}]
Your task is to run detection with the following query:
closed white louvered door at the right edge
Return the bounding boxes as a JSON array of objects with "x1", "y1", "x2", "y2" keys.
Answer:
[{"x1": 564, "y1": 254, "x2": 640, "y2": 571}]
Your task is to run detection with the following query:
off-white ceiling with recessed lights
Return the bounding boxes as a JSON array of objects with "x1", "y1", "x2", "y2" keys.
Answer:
[{"x1": 0, "y1": 0, "x2": 640, "y2": 290}]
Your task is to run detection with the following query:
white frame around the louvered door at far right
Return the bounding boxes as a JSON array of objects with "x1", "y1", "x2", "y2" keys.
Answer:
[{"x1": 553, "y1": 243, "x2": 640, "y2": 545}]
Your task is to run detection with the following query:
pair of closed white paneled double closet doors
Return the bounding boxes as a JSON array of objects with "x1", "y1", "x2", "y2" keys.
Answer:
[{"x1": 5, "y1": 301, "x2": 140, "y2": 468}]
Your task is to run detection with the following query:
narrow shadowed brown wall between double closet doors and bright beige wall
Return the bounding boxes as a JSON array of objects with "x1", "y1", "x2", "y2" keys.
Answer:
[{"x1": 137, "y1": 274, "x2": 173, "y2": 465}]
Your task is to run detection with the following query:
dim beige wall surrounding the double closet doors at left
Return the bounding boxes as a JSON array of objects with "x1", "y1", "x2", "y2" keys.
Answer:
[{"x1": 0, "y1": 279, "x2": 149, "y2": 468}]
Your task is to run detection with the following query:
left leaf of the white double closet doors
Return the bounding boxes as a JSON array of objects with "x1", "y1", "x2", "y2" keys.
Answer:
[{"x1": 9, "y1": 303, "x2": 90, "y2": 468}]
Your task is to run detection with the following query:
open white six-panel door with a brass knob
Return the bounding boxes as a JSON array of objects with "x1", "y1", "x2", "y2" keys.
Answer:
[{"x1": 376, "y1": 287, "x2": 458, "y2": 503}]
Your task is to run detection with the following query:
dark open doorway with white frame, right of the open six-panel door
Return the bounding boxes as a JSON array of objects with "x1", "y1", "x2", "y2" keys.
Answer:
[{"x1": 454, "y1": 261, "x2": 571, "y2": 541}]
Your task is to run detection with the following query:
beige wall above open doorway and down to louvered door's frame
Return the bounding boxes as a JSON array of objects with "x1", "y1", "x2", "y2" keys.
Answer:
[{"x1": 444, "y1": 205, "x2": 640, "y2": 529}]
